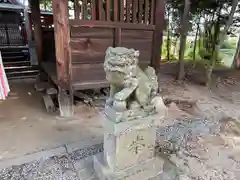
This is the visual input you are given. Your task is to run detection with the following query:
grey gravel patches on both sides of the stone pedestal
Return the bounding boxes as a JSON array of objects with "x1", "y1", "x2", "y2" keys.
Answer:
[{"x1": 0, "y1": 116, "x2": 225, "y2": 180}]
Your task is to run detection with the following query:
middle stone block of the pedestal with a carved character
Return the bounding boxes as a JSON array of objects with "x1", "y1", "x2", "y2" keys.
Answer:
[{"x1": 104, "y1": 127, "x2": 156, "y2": 171}]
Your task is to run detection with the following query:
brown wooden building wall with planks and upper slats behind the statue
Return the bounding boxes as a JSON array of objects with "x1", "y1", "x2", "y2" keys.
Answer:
[{"x1": 69, "y1": 0, "x2": 164, "y2": 89}]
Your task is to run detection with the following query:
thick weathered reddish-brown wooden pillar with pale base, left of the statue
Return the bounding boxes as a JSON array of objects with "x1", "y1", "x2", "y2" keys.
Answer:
[{"x1": 52, "y1": 0, "x2": 73, "y2": 117}]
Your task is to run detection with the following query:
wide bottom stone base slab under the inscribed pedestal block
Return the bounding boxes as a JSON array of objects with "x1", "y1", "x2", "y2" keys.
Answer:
[{"x1": 93, "y1": 153, "x2": 164, "y2": 180}]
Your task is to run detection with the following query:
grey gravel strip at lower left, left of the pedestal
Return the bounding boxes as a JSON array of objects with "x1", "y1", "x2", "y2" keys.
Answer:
[{"x1": 0, "y1": 144, "x2": 103, "y2": 180}]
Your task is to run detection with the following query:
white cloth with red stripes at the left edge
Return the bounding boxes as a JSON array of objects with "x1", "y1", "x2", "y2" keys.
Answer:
[{"x1": 0, "y1": 52, "x2": 10, "y2": 100}]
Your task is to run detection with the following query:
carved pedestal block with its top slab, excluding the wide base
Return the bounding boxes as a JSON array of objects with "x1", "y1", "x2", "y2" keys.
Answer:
[{"x1": 104, "y1": 116, "x2": 160, "y2": 171}]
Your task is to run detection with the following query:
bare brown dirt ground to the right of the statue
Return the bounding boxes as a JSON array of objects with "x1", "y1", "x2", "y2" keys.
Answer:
[{"x1": 160, "y1": 68, "x2": 240, "y2": 180}]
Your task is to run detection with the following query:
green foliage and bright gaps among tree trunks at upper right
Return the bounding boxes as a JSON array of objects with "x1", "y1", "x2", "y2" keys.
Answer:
[{"x1": 163, "y1": 0, "x2": 240, "y2": 84}]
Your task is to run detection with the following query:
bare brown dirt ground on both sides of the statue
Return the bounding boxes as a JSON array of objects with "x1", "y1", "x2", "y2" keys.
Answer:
[{"x1": 0, "y1": 67, "x2": 240, "y2": 180}]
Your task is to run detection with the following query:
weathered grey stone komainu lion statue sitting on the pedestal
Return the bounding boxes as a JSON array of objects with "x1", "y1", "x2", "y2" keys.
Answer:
[{"x1": 104, "y1": 47, "x2": 165, "y2": 121}]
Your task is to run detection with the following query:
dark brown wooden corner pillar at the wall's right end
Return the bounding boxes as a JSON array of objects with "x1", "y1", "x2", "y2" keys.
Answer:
[{"x1": 151, "y1": 0, "x2": 165, "y2": 73}]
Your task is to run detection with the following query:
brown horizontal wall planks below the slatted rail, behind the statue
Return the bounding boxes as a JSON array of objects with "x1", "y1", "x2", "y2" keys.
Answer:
[{"x1": 70, "y1": 23, "x2": 153, "y2": 89}]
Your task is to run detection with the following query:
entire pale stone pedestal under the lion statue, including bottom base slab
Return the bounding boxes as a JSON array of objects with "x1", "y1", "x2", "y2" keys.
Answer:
[{"x1": 94, "y1": 110, "x2": 163, "y2": 180}]
